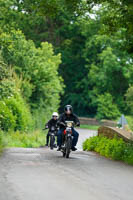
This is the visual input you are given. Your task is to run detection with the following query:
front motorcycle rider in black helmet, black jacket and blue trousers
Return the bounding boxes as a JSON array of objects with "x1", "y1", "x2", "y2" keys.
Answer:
[{"x1": 57, "y1": 105, "x2": 80, "y2": 151}]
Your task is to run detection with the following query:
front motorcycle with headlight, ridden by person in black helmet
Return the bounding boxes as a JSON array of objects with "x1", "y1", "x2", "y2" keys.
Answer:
[{"x1": 61, "y1": 121, "x2": 74, "y2": 158}]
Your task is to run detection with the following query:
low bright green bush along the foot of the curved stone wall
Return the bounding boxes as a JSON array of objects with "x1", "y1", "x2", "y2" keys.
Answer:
[{"x1": 83, "y1": 136, "x2": 133, "y2": 165}]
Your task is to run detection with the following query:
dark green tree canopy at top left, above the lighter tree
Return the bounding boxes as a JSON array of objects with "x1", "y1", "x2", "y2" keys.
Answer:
[{"x1": 0, "y1": 0, "x2": 85, "y2": 46}]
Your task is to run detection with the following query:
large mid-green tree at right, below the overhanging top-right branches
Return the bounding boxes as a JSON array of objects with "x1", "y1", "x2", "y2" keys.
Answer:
[{"x1": 83, "y1": 23, "x2": 133, "y2": 112}]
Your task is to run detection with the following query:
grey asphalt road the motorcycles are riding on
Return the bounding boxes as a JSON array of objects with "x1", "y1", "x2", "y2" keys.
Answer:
[{"x1": 0, "y1": 130, "x2": 133, "y2": 200}]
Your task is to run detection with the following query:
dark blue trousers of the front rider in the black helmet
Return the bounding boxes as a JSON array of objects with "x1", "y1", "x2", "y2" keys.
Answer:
[{"x1": 57, "y1": 128, "x2": 79, "y2": 147}]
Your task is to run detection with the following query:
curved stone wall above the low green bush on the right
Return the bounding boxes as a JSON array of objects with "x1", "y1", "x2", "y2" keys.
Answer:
[{"x1": 98, "y1": 126, "x2": 133, "y2": 142}]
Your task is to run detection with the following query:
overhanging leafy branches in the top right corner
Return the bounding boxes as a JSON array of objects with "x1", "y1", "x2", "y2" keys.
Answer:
[{"x1": 87, "y1": 0, "x2": 133, "y2": 53}]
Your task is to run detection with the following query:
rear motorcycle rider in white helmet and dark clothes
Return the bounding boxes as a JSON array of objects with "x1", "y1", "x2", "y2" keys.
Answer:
[{"x1": 45, "y1": 112, "x2": 58, "y2": 146}]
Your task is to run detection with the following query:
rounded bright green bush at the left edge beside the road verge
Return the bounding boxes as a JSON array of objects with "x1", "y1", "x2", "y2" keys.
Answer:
[{"x1": 0, "y1": 96, "x2": 33, "y2": 131}]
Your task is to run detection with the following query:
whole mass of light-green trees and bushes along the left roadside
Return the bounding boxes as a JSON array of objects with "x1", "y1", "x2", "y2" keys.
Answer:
[{"x1": 0, "y1": 28, "x2": 62, "y2": 131}]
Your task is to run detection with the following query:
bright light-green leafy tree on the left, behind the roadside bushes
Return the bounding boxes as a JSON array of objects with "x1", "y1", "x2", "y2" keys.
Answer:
[{"x1": 0, "y1": 31, "x2": 62, "y2": 110}]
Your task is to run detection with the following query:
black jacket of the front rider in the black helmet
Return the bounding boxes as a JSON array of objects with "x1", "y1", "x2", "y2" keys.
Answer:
[{"x1": 57, "y1": 113, "x2": 80, "y2": 128}]
